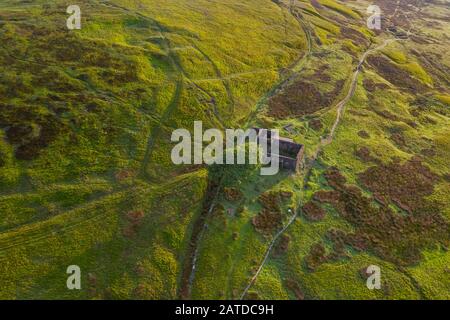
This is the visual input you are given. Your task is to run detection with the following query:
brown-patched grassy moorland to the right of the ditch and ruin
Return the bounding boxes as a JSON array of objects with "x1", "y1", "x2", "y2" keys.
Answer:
[{"x1": 192, "y1": 1, "x2": 450, "y2": 299}]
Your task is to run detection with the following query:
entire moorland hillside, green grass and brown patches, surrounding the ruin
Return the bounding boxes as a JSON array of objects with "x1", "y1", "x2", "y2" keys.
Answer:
[{"x1": 0, "y1": 0, "x2": 450, "y2": 299}]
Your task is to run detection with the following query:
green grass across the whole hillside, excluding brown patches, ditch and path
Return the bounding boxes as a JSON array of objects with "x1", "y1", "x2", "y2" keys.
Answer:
[{"x1": 0, "y1": 0, "x2": 450, "y2": 299}]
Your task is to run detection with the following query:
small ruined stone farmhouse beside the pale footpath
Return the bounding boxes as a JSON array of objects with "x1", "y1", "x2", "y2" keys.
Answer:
[{"x1": 253, "y1": 128, "x2": 305, "y2": 172}]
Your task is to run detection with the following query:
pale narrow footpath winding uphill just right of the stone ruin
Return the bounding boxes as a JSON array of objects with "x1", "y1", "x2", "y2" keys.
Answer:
[{"x1": 240, "y1": 35, "x2": 400, "y2": 300}]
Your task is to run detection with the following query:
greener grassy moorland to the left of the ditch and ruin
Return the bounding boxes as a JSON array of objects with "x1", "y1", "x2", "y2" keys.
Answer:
[{"x1": 0, "y1": 1, "x2": 306, "y2": 299}]
